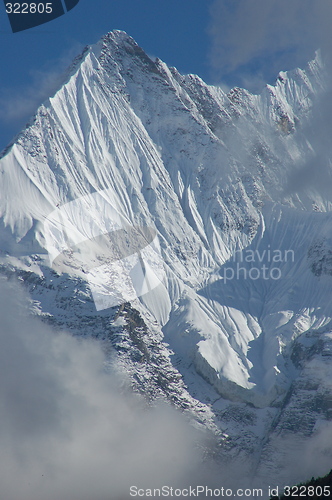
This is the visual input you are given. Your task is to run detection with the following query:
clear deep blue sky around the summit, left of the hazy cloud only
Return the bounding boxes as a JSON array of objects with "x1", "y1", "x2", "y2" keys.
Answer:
[{"x1": 0, "y1": 0, "x2": 211, "y2": 149}]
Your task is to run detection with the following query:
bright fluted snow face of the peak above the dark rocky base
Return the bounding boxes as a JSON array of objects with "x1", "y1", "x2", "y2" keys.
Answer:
[{"x1": 0, "y1": 32, "x2": 330, "y2": 412}]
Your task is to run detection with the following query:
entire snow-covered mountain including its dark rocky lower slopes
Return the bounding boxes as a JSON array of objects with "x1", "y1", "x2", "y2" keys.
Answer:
[{"x1": 0, "y1": 31, "x2": 332, "y2": 484}]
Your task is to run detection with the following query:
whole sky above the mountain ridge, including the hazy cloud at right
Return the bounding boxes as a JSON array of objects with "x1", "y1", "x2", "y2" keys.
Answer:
[{"x1": 0, "y1": 0, "x2": 332, "y2": 150}]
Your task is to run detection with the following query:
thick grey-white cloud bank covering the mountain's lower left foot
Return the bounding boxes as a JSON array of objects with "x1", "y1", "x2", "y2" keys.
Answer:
[{"x1": 0, "y1": 281, "x2": 208, "y2": 500}]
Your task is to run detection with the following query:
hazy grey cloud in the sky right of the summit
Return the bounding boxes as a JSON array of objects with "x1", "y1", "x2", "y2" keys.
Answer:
[{"x1": 209, "y1": 0, "x2": 332, "y2": 90}]
